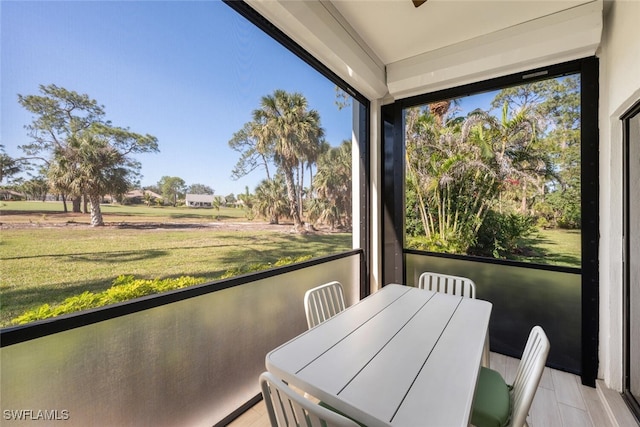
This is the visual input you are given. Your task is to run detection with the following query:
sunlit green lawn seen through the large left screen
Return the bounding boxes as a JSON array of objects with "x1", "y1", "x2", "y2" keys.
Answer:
[{"x1": 0, "y1": 202, "x2": 351, "y2": 327}]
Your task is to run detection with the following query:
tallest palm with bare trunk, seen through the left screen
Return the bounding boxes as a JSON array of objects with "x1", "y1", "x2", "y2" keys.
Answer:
[{"x1": 253, "y1": 90, "x2": 324, "y2": 231}]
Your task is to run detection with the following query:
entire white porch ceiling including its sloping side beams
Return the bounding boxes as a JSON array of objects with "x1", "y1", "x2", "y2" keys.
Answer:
[{"x1": 245, "y1": 0, "x2": 603, "y2": 98}]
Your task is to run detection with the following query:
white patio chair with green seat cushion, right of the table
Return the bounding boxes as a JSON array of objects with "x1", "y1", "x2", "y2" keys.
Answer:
[{"x1": 471, "y1": 326, "x2": 550, "y2": 427}]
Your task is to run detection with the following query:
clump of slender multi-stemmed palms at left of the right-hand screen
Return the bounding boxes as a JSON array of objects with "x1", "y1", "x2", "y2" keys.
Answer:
[{"x1": 405, "y1": 108, "x2": 495, "y2": 252}]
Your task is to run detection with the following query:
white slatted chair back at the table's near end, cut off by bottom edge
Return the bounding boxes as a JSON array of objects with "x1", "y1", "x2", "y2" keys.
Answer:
[{"x1": 260, "y1": 372, "x2": 358, "y2": 427}]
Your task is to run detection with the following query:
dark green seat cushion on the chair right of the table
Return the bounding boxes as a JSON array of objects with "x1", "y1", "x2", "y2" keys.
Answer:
[{"x1": 471, "y1": 368, "x2": 511, "y2": 427}]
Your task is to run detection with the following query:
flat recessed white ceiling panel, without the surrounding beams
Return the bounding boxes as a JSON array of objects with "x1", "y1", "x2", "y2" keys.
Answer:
[{"x1": 330, "y1": 0, "x2": 592, "y2": 65}]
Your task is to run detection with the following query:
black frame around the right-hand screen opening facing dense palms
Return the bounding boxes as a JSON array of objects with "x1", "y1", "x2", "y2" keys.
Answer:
[{"x1": 380, "y1": 57, "x2": 599, "y2": 387}]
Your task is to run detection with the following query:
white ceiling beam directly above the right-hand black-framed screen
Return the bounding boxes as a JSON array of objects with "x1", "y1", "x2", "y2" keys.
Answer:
[{"x1": 387, "y1": 0, "x2": 603, "y2": 99}]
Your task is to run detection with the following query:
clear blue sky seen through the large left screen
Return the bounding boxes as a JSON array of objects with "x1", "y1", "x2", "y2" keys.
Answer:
[{"x1": 0, "y1": 0, "x2": 351, "y2": 195}]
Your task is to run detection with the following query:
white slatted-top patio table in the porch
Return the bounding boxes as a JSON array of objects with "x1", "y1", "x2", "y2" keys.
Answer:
[{"x1": 266, "y1": 284, "x2": 492, "y2": 427}]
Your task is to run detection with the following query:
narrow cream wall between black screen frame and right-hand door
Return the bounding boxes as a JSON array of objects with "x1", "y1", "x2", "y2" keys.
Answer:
[{"x1": 597, "y1": 0, "x2": 640, "y2": 391}]
